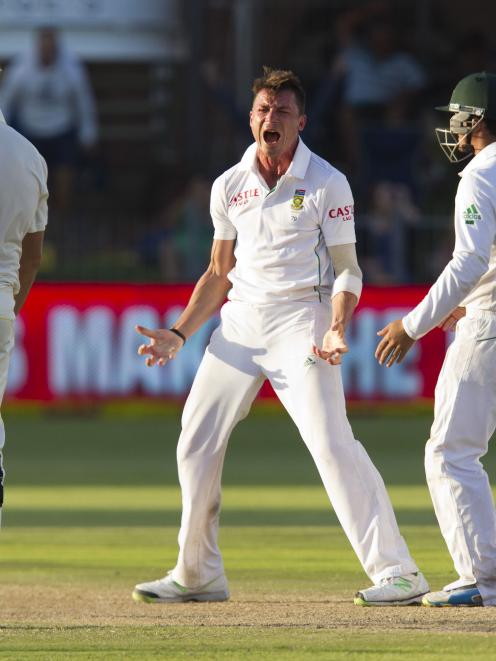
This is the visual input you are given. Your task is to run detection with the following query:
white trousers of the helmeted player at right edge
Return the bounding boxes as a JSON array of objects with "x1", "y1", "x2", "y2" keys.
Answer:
[{"x1": 425, "y1": 311, "x2": 496, "y2": 606}]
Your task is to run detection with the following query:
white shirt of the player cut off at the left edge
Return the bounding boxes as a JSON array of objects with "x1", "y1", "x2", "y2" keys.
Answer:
[{"x1": 0, "y1": 113, "x2": 48, "y2": 316}]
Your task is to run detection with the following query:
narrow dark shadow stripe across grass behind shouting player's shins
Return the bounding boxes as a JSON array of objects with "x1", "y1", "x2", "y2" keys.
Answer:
[{"x1": 3, "y1": 507, "x2": 436, "y2": 527}]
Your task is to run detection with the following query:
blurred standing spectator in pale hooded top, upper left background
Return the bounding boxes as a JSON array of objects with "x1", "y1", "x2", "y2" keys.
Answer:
[{"x1": 0, "y1": 28, "x2": 97, "y2": 260}]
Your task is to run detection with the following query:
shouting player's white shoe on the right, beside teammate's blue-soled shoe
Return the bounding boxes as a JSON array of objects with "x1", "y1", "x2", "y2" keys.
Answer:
[{"x1": 354, "y1": 572, "x2": 429, "y2": 606}]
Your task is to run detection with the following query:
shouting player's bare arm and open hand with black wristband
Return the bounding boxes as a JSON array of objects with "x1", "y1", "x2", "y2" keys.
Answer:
[{"x1": 136, "y1": 240, "x2": 236, "y2": 367}]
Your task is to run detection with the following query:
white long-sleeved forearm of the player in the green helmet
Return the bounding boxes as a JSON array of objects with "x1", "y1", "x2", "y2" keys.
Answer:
[{"x1": 402, "y1": 253, "x2": 487, "y2": 340}]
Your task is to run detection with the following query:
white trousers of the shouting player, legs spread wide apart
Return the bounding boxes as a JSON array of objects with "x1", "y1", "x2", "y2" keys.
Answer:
[{"x1": 172, "y1": 301, "x2": 417, "y2": 588}]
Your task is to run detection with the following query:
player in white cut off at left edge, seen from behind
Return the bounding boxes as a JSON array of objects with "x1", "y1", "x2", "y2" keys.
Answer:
[{"x1": 0, "y1": 107, "x2": 48, "y2": 514}]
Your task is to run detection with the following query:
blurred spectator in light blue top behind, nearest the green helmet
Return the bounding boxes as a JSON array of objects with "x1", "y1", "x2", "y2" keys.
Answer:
[{"x1": 326, "y1": 2, "x2": 425, "y2": 196}]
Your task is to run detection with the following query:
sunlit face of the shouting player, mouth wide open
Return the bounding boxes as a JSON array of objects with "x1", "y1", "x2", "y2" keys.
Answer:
[{"x1": 250, "y1": 89, "x2": 307, "y2": 159}]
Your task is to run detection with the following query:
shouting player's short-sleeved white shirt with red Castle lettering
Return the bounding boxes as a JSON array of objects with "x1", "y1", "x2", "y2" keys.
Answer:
[{"x1": 210, "y1": 139, "x2": 356, "y2": 303}]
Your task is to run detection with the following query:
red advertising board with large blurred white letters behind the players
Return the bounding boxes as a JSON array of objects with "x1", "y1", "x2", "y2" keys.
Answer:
[{"x1": 7, "y1": 283, "x2": 447, "y2": 403}]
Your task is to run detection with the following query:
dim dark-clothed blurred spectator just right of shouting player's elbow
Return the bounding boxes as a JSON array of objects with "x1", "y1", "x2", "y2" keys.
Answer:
[{"x1": 357, "y1": 181, "x2": 420, "y2": 284}]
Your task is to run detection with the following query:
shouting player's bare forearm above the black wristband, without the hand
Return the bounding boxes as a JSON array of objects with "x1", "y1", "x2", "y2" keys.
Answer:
[{"x1": 170, "y1": 269, "x2": 232, "y2": 338}]
